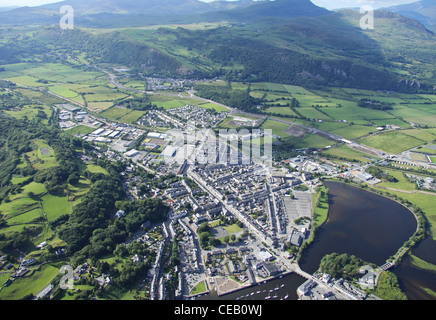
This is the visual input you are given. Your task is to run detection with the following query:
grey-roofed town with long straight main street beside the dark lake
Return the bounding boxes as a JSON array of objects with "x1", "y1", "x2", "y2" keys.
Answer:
[{"x1": 33, "y1": 90, "x2": 435, "y2": 300}]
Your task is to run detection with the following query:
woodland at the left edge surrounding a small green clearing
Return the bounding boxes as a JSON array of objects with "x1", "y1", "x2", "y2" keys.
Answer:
[{"x1": 0, "y1": 114, "x2": 88, "y2": 251}]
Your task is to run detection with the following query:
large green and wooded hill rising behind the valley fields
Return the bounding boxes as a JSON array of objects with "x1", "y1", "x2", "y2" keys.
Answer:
[{"x1": 15, "y1": 7, "x2": 430, "y2": 92}]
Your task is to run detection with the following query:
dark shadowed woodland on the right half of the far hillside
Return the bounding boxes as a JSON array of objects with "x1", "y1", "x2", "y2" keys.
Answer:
[{"x1": 171, "y1": 23, "x2": 431, "y2": 91}]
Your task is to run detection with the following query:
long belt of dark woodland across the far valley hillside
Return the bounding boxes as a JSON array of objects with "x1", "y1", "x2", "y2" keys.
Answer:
[{"x1": 0, "y1": 25, "x2": 433, "y2": 92}]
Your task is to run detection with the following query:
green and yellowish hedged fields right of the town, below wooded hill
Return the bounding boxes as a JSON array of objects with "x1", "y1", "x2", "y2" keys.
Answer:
[{"x1": 240, "y1": 83, "x2": 436, "y2": 152}]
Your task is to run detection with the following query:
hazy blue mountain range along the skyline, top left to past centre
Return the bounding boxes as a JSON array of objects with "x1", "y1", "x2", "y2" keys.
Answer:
[{"x1": 0, "y1": 0, "x2": 329, "y2": 28}]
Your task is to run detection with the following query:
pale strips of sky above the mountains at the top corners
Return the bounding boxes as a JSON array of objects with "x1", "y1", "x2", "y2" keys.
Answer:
[{"x1": 0, "y1": 0, "x2": 418, "y2": 10}]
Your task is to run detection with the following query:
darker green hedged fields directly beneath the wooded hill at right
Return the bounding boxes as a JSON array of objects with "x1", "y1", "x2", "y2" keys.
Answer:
[{"x1": 245, "y1": 83, "x2": 436, "y2": 128}]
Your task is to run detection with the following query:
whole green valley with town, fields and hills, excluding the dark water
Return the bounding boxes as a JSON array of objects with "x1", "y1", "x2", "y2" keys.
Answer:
[{"x1": 0, "y1": 0, "x2": 436, "y2": 300}]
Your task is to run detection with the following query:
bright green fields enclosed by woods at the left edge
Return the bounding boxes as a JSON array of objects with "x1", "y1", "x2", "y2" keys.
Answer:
[{"x1": 0, "y1": 139, "x2": 107, "y2": 242}]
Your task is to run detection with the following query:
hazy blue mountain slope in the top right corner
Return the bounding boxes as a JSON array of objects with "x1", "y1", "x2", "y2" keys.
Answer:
[{"x1": 386, "y1": 0, "x2": 436, "y2": 31}]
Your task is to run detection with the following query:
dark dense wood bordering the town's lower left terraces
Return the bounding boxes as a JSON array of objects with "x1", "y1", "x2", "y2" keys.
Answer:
[{"x1": 66, "y1": 195, "x2": 169, "y2": 265}]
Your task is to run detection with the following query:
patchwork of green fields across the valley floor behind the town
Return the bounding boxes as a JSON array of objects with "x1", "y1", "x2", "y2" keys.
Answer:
[{"x1": 0, "y1": 63, "x2": 436, "y2": 155}]
